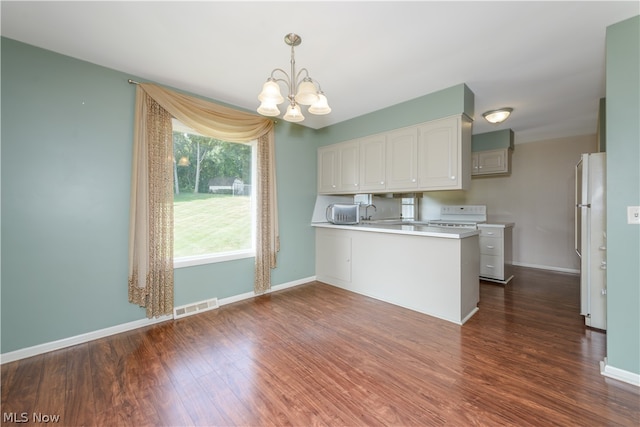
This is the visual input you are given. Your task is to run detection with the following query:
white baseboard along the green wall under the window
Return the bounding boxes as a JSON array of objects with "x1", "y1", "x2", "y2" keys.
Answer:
[{"x1": 0, "y1": 276, "x2": 315, "y2": 364}]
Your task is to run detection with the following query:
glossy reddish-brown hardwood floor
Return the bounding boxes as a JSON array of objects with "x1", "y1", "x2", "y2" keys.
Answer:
[{"x1": 2, "y1": 268, "x2": 640, "y2": 426}]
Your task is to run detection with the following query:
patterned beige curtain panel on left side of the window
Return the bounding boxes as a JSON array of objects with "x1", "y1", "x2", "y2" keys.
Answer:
[{"x1": 129, "y1": 87, "x2": 173, "y2": 318}]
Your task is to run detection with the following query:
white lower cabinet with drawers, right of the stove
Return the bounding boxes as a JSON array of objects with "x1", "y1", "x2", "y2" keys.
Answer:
[{"x1": 478, "y1": 224, "x2": 513, "y2": 284}]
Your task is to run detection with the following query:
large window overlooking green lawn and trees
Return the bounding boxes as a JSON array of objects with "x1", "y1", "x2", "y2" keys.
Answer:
[{"x1": 173, "y1": 119, "x2": 256, "y2": 268}]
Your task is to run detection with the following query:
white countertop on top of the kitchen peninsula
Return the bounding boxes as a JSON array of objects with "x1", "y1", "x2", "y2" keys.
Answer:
[{"x1": 311, "y1": 222, "x2": 480, "y2": 239}]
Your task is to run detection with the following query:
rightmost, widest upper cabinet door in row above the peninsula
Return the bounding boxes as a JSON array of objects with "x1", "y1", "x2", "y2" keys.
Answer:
[{"x1": 418, "y1": 117, "x2": 461, "y2": 190}]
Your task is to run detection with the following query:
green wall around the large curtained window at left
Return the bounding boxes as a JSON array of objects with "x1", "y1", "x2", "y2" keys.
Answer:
[{"x1": 0, "y1": 38, "x2": 317, "y2": 353}]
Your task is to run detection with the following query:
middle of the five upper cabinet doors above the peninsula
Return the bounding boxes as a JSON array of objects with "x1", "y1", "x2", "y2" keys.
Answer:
[{"x1": 360, "y1": 135, "x2": 387, "y2": 191}]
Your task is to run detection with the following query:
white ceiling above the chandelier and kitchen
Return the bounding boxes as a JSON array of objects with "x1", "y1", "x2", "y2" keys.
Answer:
[{"x1": 1, "y1": 1, "x2": 640, "y2": 143}]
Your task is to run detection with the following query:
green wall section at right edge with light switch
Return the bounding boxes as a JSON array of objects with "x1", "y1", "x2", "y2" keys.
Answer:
[{"x1": 606, "y1": 16, "x2": 640, "y2": 374}]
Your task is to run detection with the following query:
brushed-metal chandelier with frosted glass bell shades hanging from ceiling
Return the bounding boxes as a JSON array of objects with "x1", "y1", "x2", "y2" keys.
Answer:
[{"x1": 258, "y1": 33, "x2": 331, "y2": 122}]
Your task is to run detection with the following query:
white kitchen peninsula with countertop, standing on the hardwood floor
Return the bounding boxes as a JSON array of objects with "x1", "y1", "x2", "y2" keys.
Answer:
[{"x1": 312, "y1": 222, "x2": 480, "y2": 325}]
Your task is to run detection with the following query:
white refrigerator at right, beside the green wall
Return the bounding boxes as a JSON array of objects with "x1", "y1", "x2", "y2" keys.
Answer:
[{"x1": 575, "y1": 153, "x2": 607, "y2": 330}]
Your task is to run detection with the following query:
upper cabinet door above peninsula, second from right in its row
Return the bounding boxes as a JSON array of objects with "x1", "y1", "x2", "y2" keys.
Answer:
[{"x1": 386, "y1": 128, "x2": 418, "y2": 190}]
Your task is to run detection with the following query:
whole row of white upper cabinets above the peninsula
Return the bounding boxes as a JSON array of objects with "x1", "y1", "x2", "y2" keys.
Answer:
[{"x1": 318, "y1": 115, "x2": 472, "y2": 194}]
